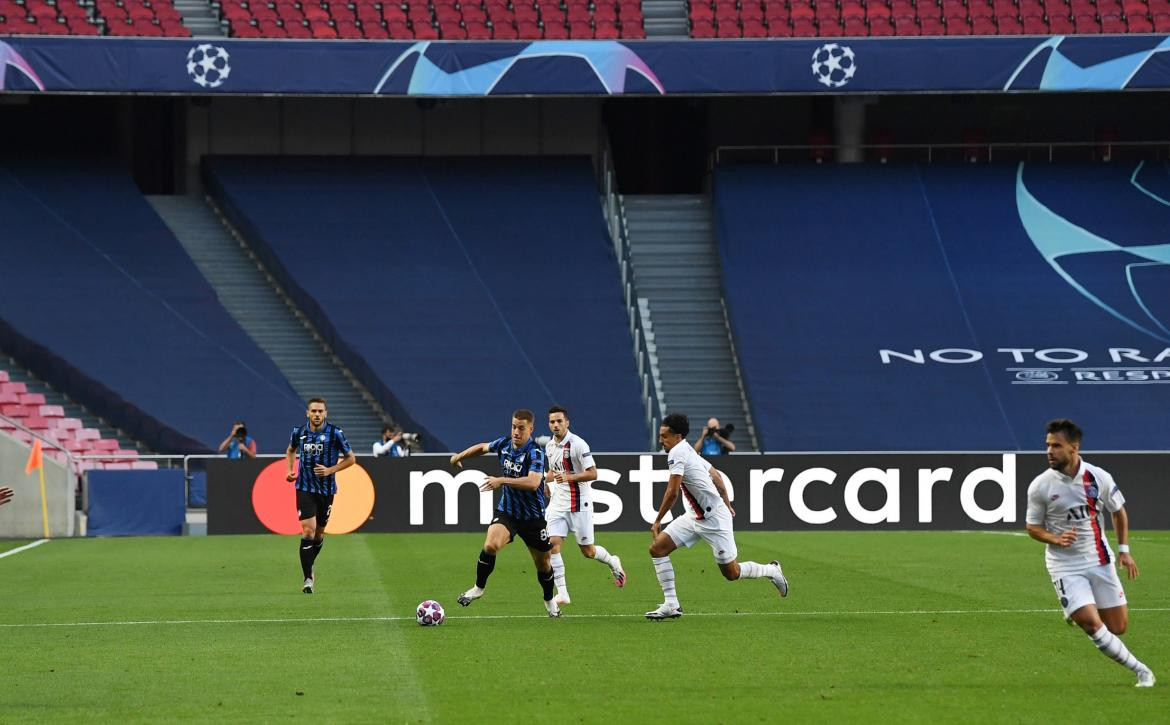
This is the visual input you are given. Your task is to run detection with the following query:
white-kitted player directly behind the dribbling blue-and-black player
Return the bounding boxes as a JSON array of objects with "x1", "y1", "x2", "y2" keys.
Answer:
[{"x1": 544, "y1": 406, "x2": 626, "y2": 605}]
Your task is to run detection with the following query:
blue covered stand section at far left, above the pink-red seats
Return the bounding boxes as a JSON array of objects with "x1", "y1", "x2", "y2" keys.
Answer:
[{"x1": 0, "y1": 160, "x2": 304, "y2": 453}]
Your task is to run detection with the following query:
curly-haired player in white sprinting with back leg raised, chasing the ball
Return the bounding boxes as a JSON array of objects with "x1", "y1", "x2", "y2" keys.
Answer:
[{"x1": 646, "y1": 413, "x2": 789, "y2": 620}]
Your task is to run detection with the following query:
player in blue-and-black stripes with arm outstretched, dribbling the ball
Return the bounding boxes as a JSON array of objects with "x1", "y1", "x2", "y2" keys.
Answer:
[{"x1": 450, "y1": 409, "x2": 560, "y2": 617}]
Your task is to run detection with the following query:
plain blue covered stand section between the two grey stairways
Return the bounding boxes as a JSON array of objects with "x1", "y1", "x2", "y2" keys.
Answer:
[{"x1": 204, "y1": 157, "x2": 648, "y2": 450}]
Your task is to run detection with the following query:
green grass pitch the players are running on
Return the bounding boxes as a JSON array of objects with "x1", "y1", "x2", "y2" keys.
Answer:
[{"x1": 0, "y1": 531, "x2": 1170, "y2": 724}]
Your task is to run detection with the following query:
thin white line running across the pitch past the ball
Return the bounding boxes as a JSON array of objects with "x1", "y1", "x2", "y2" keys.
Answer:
[{"x1": 0, "y1": 607, "x2": 1170, "y2": 629}]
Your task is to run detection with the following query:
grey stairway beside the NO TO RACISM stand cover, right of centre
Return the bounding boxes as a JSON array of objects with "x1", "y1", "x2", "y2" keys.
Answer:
[{"x1": 622, "y1": 194, "x2": 756, "y2": 451}]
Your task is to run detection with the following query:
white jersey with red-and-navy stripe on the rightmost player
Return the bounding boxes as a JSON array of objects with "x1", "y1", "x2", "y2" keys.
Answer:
[{"x1": 1026, "y1": 458, "x2": 1126, "y2": 576}]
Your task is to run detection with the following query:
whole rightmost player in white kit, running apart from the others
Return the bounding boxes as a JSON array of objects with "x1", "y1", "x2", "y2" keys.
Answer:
[{"x1": 1026, "y1": 419, "x2": 1155, "y2": 688}]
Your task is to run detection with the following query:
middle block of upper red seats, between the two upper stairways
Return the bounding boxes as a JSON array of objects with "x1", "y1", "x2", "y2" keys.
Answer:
[{"x1": 214, "y1": 0, "x2": 646, "y2": 40}]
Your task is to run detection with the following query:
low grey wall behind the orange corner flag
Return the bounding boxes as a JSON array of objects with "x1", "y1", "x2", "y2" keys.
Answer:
[{"x1": 0, "y1": 435, "x2": 75, "y2": 539}]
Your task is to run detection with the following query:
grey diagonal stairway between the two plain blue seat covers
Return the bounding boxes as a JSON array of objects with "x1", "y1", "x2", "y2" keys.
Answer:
[{"x1": 147, "y1": 196, "x2": 390, "y2": 454}]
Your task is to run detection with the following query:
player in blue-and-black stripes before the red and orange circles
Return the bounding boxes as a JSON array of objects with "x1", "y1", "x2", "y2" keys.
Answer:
[{"x1": 284, "y1": 398, "x2": 357, "y2": 594}]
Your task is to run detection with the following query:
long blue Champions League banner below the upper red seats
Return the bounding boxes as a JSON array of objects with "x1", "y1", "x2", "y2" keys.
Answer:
[{"x1": 0, "y1": 35, "x2": 1170, "y2": 97}]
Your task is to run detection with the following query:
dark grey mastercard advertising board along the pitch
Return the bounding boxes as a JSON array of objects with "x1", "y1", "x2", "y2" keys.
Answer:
[{"x1": 207, "y1": 453, "x2": 1170, "y2": 533}]
